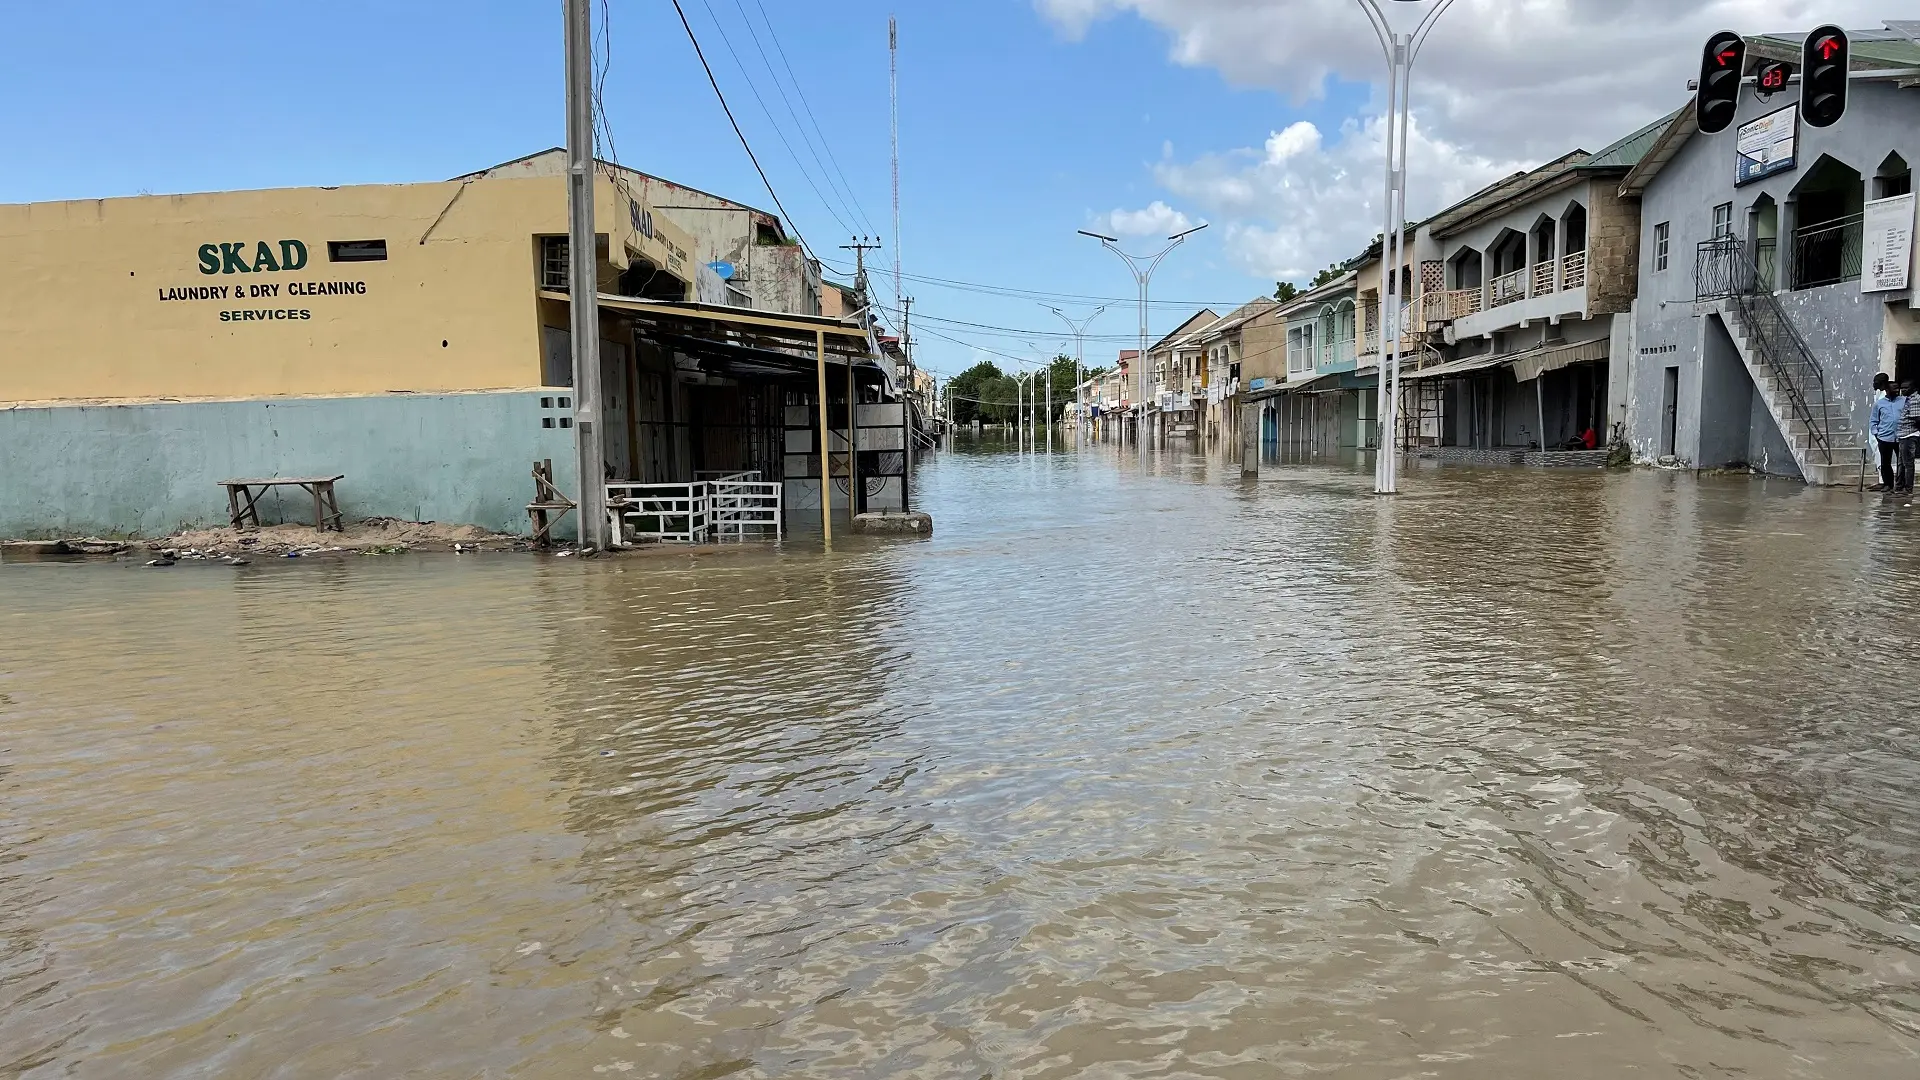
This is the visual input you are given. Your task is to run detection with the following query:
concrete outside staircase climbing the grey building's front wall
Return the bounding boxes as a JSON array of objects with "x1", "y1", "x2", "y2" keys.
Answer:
[{"x1": 1718, "y1": 294, "x2": 1868, "y2": 486}]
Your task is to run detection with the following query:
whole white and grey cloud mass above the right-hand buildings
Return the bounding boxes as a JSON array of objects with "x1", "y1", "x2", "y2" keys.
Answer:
[{"x1": 1033, "y1": 0, "x2": 1910, "y2": 279}]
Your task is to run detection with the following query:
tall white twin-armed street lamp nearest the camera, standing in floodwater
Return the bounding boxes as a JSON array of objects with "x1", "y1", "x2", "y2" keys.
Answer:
[{"x1": 1359, "y1": 0, "x2": 1453, "y2": 496}]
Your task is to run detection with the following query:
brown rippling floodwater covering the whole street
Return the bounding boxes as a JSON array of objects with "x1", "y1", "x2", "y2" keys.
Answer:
[{"x1": 0, "y1": 444, "x2": 1920, "y2": 1080}]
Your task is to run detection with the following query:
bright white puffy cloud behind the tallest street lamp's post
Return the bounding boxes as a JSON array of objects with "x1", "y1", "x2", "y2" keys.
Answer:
[{"x1": 1154, "y1": 119, "x2": 1524, "y2": 281}]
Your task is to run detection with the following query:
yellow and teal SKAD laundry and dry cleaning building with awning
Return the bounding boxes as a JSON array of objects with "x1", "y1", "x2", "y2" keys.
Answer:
[{"x1": 0, "y1": 153, "x2": 904, "y2": 536}]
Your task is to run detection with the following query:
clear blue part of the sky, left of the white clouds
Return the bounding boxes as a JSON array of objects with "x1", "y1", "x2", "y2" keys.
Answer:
[{"x1": 0, "y1": 0, "x2": 1359, "y2": 371}]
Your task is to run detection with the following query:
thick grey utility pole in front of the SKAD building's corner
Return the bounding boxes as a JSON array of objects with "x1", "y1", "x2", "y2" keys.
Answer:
[{"x1": 566, "y1": 0, "x2": 612, "y2": 552}]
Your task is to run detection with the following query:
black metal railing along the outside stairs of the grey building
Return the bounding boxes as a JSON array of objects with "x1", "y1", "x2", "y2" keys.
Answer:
[{"x1": 1693, "y1": 236, "x2": 1834, "y2": 465}]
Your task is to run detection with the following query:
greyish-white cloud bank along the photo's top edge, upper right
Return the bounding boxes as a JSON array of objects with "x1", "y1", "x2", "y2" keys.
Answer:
[{"x1": 1035, "y1": 0, "x2": 1910, "y2": 161}]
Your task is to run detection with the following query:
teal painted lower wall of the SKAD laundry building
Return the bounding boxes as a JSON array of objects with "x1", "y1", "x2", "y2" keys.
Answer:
[{"x1": 0, "y1": 390, "x2": 578, "y2": 538}]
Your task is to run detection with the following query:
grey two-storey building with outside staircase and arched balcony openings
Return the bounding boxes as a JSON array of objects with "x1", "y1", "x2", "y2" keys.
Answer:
[{"x1": 1620, "y1": 31, "x2": 1920, "y2": 484}]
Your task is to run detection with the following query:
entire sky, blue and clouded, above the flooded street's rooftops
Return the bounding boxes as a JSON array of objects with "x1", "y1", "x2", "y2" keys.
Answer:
[{"x1": 0, "y1": 0, "x2": 1910, "y2": 375}]
